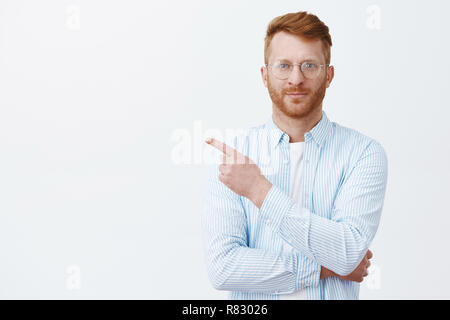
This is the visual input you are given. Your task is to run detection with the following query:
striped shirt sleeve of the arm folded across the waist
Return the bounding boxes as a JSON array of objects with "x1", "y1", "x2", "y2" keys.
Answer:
[{"x1": 202, "y1": 165, "x2": 321, "y2": 294}]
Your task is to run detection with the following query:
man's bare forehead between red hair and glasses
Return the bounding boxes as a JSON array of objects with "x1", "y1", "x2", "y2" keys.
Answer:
[{"x1": 269, "y1": 32, "x2": 325, "y2": 62}]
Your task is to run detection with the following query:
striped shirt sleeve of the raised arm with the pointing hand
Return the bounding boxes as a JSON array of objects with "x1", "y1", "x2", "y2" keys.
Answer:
[{"x1": 259, "y1": 141, "x2": 387, "y2": 276}]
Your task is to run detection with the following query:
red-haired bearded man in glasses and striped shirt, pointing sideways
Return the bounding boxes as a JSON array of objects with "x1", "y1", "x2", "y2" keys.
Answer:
[{"x1": 203, "y1": 12, "x2": 387, "y2": 299}]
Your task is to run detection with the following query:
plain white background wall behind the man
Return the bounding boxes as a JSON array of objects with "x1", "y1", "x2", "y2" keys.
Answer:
[{"x1": 0, "y1": 0, "x2": 450, "y2": 299}]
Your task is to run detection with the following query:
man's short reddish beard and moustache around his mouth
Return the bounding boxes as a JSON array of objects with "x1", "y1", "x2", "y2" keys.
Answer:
[{"x1": 267, "y1": 78, "x2": 327, "y2": 119}]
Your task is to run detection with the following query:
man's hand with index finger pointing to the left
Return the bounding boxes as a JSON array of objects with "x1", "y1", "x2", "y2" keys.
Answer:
[{"x1": 206, "y1": 138, "x2": 272, "y2": 209}]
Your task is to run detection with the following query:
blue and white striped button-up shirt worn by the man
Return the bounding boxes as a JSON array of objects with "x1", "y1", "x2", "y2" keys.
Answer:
[{"x1": 202, "y1": 111, "x2": 387, "y2": 299}]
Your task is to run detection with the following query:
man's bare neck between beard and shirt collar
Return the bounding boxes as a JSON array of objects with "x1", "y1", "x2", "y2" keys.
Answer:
[{"x1": 272, "y1": 105, "x2": 322, "y2": 143}]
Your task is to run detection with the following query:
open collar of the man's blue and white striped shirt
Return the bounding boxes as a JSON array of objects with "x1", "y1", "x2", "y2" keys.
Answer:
[{"x1": 266, "y1": 110, "x2": 332, "y2": 148}]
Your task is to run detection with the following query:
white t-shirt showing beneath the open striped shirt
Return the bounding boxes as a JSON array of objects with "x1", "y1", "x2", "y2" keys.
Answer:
[{"x1": 279, "y1": 142, "x2": 307, "y2": 300}]
